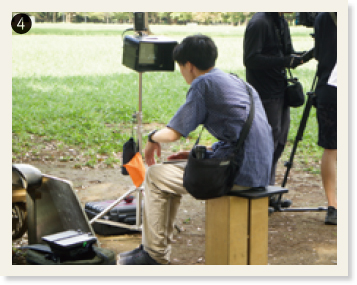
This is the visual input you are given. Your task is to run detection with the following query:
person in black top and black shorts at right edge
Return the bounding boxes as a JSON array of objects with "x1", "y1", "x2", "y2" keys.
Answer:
[{"x1": 315, "y1": 13, "x2": 337, "y2": 225}]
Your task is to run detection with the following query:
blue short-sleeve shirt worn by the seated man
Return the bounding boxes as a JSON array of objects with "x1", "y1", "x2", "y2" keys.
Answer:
[{"x1": 167, "y1": 68, "x2": 274, "y2": 187}]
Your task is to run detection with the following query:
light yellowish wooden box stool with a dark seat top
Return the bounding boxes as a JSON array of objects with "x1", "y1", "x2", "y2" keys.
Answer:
[{"x1": 206, "y1": 186, "x2": 288, "y2": 265}]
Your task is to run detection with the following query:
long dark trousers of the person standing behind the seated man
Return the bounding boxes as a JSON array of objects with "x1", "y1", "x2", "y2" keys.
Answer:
[{"x1": 262, "y1": 97, "x2": 290, "y2": 185}]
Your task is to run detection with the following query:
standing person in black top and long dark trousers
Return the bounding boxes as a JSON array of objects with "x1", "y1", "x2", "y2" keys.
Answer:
[{"x1": 243, "y1": 12, "x2": 312, "y2": 207}]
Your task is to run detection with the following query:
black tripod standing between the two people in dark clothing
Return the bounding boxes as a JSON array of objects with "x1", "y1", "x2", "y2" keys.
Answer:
[{"x1": 273, "y1": 75, "x2": 327, "y2": 212}]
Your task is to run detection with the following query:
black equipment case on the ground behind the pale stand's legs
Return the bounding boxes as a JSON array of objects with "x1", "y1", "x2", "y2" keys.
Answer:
[{"x1": 84, "y1": 196, "x2": 137, "y2": 235}]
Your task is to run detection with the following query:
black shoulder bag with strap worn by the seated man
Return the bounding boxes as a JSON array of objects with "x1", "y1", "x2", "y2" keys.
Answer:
[{"x1": 183, "y1": 81, "x2": 255, "y2": 200}]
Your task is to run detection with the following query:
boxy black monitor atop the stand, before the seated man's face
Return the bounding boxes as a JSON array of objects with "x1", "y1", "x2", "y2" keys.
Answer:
[{"x1": 123, "y1": 12, "x2": 177, "y2": 72}]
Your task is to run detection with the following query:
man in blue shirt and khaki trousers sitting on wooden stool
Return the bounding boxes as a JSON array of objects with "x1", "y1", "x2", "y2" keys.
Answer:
[{"x1": 119, "y1": 35, "x2": 273, "y2": 265}]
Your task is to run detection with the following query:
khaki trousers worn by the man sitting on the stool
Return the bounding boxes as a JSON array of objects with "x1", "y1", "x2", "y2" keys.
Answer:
[{"x1": 142, "y1": 162, "x2": 250, "y2": 264}]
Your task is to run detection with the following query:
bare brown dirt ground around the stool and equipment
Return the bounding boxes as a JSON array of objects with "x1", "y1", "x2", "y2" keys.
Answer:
[{"x1": 13, "y1": 143, "x2": 337, "y2": 265}]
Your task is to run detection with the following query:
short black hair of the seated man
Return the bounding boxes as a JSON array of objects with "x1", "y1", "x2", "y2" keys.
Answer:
[{"x1": 173, "y1": 35, "x2": 218, "y2": 70}]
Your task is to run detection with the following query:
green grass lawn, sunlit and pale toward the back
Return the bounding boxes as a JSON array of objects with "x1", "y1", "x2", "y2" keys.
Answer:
[{"x1": 12, "y1": 24, "x2": 321, "y2": 172}]
